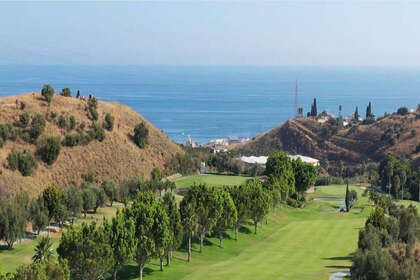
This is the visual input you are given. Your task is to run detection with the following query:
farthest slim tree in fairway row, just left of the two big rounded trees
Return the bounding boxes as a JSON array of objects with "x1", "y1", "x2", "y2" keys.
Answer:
[{"x1": 246, "y1": 179, "x2": 270, "y2": 234}]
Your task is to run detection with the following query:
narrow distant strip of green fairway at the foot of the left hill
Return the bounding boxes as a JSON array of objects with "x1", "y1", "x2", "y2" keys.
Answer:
[{"x1": 175, "y1": 174, "x2": 252, "y2": 188}]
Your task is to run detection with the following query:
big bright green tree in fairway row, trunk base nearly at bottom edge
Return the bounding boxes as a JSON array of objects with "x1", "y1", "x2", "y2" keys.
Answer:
[{"x1": 126, "y1": 192, "x2": 170, "y2": 280}]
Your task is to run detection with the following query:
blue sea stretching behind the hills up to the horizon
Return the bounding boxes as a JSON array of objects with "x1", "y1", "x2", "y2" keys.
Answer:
[{"x1": 0, "y1": 65, "x2": 420, "y2": 143}]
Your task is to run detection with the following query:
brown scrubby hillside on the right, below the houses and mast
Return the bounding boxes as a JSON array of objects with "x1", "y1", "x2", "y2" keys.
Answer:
[{"x1": 232, "y1": 114, "x2": 420, "y2": 164}]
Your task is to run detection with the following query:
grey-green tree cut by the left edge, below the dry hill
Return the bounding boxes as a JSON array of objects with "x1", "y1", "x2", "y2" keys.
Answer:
[{"x1": 0, "y1": 200, "x2": 27, "y2": 249}]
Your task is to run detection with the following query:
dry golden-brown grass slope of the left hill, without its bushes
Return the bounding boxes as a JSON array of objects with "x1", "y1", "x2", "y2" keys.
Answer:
[{"x1": 0, "y1": 93, "x2": 181, "y2": 193}]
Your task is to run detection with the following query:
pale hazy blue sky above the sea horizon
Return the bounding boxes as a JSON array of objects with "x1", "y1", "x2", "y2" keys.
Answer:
[{"x1": 0, "y1": 0, "x2": 420, "y2": 67}]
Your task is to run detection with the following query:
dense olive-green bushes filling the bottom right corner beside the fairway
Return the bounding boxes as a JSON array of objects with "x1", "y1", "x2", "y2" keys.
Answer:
[{"x1": 351, "y1": 195, "x2": 420, "y2": 280}]
